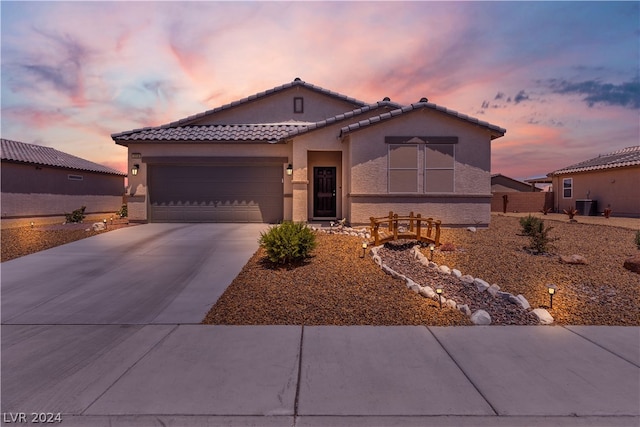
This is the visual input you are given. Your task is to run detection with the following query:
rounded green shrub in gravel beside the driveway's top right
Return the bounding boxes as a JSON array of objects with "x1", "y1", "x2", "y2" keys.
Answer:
[{"x1": 258, "y1": 221, "x2": 316, "y2": 264}]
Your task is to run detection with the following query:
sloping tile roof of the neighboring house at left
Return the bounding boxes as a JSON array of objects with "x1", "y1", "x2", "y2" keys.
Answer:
[{"x1": 0, "y1": 139, "x2": 126, "y2": 176}]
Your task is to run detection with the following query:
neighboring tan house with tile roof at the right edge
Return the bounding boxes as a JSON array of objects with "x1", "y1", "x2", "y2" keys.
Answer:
[{"x1": 549, "y1": 146, "x2": 640, "y2": 218}]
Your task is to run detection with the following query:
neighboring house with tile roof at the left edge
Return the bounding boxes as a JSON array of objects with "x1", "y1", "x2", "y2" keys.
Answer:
[{"x1": 1, "y1": 139, "x2": 126, "y2": 218}]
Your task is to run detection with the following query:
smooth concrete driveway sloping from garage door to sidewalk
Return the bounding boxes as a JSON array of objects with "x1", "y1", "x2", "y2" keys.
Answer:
[{"x1": 1, "y1": 224, "x2": 267, "y2": 325}]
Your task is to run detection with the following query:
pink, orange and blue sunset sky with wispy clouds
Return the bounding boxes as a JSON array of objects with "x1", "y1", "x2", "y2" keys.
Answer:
[{"x1": 0, "y1": 1, "x2": 640, "y2": 179}]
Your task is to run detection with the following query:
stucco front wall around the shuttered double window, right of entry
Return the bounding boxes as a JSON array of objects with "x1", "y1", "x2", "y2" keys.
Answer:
[{"x1": 348, "y1": 110, "x2": 491, "y2": 225}]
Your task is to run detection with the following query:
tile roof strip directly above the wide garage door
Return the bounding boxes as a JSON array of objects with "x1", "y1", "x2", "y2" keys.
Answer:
[{"x1": 111, "y1": 122, "x2": 311, "y2": 145}]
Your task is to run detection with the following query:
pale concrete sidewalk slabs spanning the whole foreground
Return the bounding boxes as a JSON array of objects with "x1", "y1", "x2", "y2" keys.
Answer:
[{"x1": 2, "y1": 325, "x2": 640, "y2": 426}]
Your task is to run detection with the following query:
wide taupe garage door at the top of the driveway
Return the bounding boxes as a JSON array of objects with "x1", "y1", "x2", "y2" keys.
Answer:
[{"x1": 149, "y1": 164, "x2": 283, "y2": 223}]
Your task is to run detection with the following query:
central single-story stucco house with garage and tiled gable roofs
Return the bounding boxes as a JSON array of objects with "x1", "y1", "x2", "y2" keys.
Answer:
[{"x1": 112, "y1": 79, "x2": 506, "y2": 225}]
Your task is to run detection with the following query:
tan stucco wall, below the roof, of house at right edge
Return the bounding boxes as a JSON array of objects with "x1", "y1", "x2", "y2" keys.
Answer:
[{"x1": 553, "y1": 166, "x2": 640, "y2": 218}]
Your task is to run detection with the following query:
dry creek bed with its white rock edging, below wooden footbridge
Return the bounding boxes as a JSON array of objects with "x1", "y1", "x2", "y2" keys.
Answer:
[{"x1": 370, "y1": 242, "x2": 553, "y2": 325}]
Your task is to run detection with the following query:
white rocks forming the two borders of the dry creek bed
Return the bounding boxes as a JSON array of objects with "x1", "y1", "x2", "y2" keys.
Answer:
[{"x1": 370, "y1": 246, "x2": 553, "y2": 325}]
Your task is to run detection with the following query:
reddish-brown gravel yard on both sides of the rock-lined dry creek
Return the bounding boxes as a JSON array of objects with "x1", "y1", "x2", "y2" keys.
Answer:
[{"x1": 203, "y1": 215, "x2": 640, "y2": 325}]
